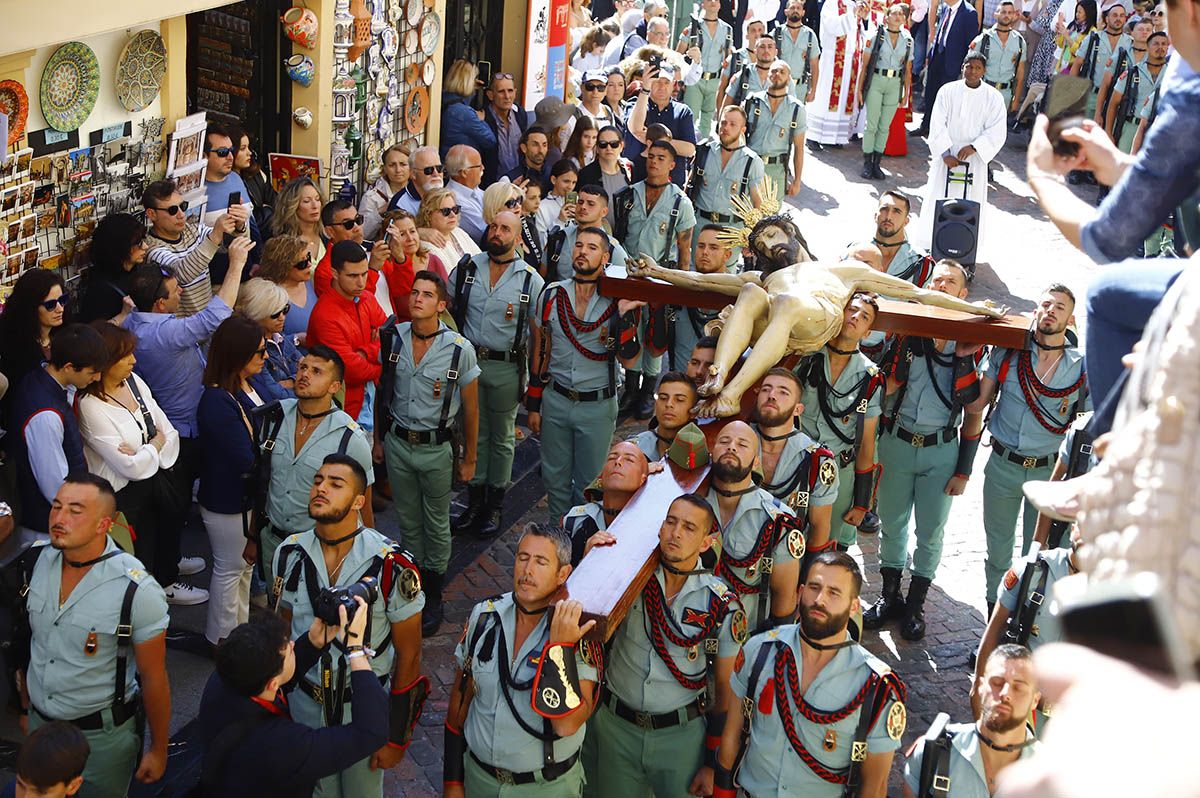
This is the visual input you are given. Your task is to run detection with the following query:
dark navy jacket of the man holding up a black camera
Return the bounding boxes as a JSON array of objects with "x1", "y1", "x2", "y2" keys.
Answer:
[{"x1": 197, "y1": 633, "x2": 388, "y2": 798}]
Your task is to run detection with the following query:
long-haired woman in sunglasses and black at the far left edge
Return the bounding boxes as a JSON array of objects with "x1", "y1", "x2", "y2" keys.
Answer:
[{"x1": 0, "y1": 269, "x2": 71, "y2": 405}]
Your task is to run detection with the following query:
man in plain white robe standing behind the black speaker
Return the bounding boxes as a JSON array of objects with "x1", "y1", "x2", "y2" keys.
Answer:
[{"x1": 920, "y1": 53, "x2": 1008, "y2": 244}]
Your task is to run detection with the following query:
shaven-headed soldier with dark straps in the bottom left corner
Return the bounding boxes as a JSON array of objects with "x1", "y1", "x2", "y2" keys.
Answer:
[{"x1": 17, "y1": 472, "x2": 170, "y2": 798}]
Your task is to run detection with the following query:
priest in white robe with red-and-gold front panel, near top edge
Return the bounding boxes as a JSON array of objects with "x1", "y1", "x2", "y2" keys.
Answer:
[{"x1": 793, "y1": 0, "x2": 870, "y2": 145}]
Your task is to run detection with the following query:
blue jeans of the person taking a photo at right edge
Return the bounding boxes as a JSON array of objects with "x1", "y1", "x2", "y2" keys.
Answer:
[{"x1": 1085, "y1": 258, "x2": 1187, "y2": 433}]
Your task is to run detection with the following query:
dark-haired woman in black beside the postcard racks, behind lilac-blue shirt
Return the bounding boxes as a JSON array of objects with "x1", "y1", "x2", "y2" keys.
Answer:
[{"x1": 79, "y1": 214, "x2": 150, "y2": 323}]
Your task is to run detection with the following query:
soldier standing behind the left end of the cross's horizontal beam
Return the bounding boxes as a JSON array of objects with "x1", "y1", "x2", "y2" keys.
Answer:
[{"x1": 613, "y1": 139, "x2": 696, "y2": 420}]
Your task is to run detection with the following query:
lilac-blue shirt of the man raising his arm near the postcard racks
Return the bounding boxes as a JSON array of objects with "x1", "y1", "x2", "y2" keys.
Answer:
[{"x1": 125, "y1": 296, "x2": 233, "y2": 438}]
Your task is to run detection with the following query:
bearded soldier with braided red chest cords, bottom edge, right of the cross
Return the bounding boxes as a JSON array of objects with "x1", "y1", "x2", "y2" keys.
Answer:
[{"x1": 713, "y1": 551, "x2": 906, "y2": 798}]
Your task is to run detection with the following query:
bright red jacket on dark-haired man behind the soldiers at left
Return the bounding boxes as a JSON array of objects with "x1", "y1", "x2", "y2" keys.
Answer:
[{"x1": 306, "y1": 290, "x2": 386, "y2": 419}]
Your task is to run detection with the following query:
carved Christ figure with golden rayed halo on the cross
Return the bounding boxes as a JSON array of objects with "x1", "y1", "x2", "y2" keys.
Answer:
[{"x1": 626, "y1": 189, "x2": 1004, "y2": 418}]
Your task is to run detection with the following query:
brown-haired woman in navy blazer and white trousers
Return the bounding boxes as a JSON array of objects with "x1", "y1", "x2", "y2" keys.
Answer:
[{"x1": 196, "y1": 314, "x2": 268, "y2": 644}]
